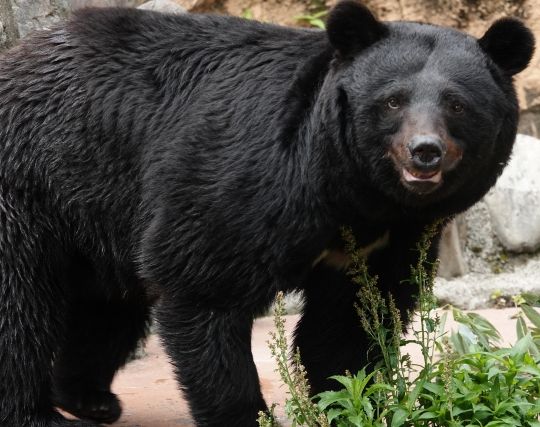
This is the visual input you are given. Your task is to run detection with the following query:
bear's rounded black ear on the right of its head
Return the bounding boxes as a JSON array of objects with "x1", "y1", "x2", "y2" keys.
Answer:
[{"x1": 478, "y1": 18, "x2": 534, "y2": 75}]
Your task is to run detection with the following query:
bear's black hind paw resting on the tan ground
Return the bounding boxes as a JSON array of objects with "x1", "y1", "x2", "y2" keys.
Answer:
[{"x1": 55, "y1": 391, "x2": 122, "y2": 427}]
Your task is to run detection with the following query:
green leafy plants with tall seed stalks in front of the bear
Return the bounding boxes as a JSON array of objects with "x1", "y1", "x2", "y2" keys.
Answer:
[{"x1": 259, "y1": 224, "x2": 540, "y2": 427}]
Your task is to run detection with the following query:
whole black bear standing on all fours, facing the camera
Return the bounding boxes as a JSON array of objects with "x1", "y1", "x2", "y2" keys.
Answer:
[{"x1": 0, "y1": 1, "x2": 534, "y2": 427}]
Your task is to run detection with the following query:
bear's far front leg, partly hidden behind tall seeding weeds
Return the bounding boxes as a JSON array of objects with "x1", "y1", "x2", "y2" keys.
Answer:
[{"x1": 295, "y1": 223, "x2": 439, "y2": 394}]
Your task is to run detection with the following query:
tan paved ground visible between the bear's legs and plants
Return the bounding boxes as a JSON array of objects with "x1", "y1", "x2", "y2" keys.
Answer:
[{"x1": 108, "y1": 309, "x2": 516, "y2": 427}]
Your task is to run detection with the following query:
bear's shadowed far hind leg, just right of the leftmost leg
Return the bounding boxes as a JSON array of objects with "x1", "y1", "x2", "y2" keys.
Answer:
[{"x1": 53, "y1": 274, "x2": 150, "y2": 423}]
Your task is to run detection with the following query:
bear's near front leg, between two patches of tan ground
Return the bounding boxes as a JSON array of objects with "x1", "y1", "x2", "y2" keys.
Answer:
[{"x1": 157, "y1": 295, "x2": 266, "y2": 427}]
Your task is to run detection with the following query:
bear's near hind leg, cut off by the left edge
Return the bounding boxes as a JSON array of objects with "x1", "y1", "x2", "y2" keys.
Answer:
[{"x1": 0, "y1": 196, "x2": 93, "y2": 427}]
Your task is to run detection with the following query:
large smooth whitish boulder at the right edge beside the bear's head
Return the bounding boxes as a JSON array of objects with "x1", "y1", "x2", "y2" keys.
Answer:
[{"x1": 485, "y1": 135, "x2": 540, "y2": 252}]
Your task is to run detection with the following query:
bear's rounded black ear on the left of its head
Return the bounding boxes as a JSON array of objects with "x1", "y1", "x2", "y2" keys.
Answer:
[{"x1": 326, "y1": 0, "x2": 387, "y2": 56}]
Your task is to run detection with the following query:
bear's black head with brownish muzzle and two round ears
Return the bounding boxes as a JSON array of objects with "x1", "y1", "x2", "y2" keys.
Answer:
[{"x1": 327, "y1": 1, "x2": 534, "y2": 211}]
